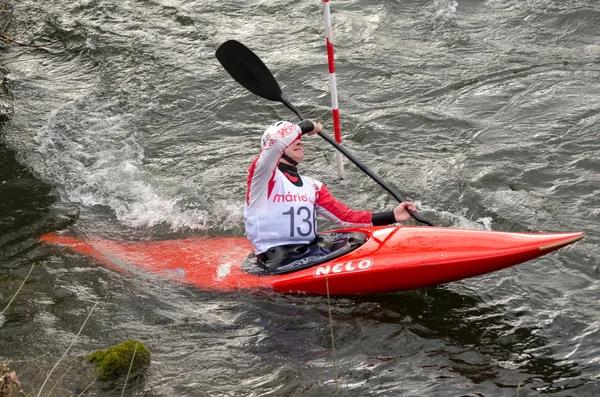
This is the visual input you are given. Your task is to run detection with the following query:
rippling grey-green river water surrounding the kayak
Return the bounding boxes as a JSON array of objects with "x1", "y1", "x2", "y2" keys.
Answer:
[{"x1": 0, "y1": 0, "x2": 600, "y2": 396}]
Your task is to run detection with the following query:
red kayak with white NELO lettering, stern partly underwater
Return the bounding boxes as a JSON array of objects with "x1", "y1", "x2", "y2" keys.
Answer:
[{"x1": 41, "y1": 226, "x2": 585, "y2": 294}]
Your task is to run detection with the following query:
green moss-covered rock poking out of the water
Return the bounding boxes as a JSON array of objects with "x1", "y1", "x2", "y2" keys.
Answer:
[{"x1": 87, "y1": 340, "x2": 150, "y2": 380}]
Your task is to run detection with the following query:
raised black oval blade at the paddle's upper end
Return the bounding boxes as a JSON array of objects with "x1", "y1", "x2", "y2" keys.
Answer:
[{"x1": 216, "y1": 40, "x2": 283, "y2": 102}]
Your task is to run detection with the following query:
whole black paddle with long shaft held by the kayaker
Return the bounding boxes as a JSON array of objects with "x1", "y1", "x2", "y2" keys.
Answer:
[{"x1": 216, "y1": 40, "x2": 434, "y2": 226}]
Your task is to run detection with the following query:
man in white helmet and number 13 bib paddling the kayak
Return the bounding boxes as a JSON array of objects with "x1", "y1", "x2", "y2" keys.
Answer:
[{"x1": 244, "y1": 120, "x2": 417, "y2": 270}]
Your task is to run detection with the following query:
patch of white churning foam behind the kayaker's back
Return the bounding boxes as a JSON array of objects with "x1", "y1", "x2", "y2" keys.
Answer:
[{"x1": 36, "y1": 98, "x2": 243, "y2": 230}]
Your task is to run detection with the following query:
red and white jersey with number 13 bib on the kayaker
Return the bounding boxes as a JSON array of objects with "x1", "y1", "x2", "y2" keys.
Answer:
[{"x1": 244, "y1": 119, "x2": 372, "y2": 254}]
